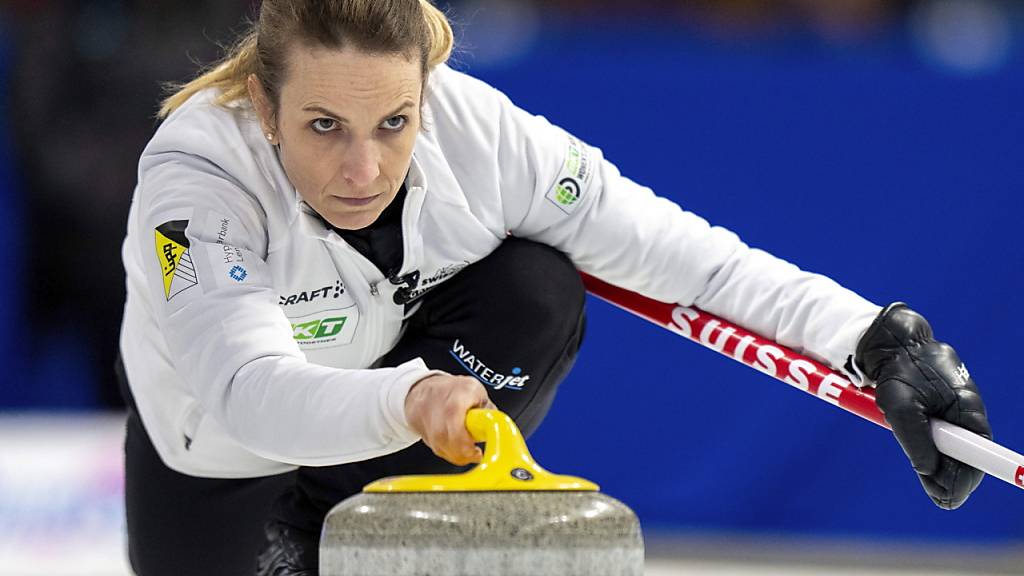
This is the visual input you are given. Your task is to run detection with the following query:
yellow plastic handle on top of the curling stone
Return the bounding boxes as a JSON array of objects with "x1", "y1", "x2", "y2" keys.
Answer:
[{"x1": 362, "y1": 409, "x2": 599, "y2": 492}]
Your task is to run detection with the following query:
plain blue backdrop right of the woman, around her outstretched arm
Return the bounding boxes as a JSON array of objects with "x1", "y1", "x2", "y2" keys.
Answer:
[{"x1": 467, "y1": 25, "x2": 1024, "y2": 543}]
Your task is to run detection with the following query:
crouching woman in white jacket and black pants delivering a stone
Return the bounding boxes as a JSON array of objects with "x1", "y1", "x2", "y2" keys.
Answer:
[{"x1": 121, "y1": 0, "x2": 990, "y2": 576}]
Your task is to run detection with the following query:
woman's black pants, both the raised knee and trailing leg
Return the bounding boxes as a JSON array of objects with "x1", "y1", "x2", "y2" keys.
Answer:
[{"x1": 120, "y1": 239, "x2": 585, "y2": 576}]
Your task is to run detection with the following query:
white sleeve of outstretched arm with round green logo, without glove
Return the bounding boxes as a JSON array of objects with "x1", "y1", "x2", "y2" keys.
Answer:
[{"x1": 494, "y1": 88, "x2": 880, "y2": 373}]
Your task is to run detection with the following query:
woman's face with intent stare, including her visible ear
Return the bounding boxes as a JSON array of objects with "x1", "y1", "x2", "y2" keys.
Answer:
[{"x1": 250, "y1": 45, "x2": 423, "y2": 230}]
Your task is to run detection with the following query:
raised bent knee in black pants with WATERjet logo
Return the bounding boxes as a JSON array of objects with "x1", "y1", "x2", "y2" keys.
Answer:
[{"x1": 383, "y1": 238, "x2": 585, "y2": 436}]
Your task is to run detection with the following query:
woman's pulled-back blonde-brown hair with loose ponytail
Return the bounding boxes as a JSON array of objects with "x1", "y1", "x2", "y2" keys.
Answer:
[{"x1": 157, "y1": 0, "x2": 455, "y2": 118}]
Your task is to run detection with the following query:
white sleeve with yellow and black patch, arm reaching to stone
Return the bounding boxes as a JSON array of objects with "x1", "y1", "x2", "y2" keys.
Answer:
[{"x1": 136, "y1": 153, "x2": 431, "y2": 465}]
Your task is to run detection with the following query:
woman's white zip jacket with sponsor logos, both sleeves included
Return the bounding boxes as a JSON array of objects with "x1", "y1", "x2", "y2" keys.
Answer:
[{"x1": 121, "y1": 61, "x2": 879, "y2": 478}]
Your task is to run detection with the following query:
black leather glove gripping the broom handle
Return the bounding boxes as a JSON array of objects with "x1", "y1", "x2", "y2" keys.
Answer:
[{"x1": 855, "y1": 302, "x2": 992, "y2": 509}]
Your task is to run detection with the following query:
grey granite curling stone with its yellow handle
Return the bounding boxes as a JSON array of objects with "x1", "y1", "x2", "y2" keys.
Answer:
[{"x1": 319, "y1": 410, "x2": 643, "y2": 576}]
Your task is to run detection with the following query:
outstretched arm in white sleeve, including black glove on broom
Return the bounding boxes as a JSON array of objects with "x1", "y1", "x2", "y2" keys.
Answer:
[{"x1": 479, "y1": 77, "x2": 991, "y2": 508}]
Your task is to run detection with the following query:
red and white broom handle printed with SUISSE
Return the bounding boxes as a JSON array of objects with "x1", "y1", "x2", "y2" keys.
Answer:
[{"x1": 581, "y1": 273, "x2": 1024, "y2": 488}]
